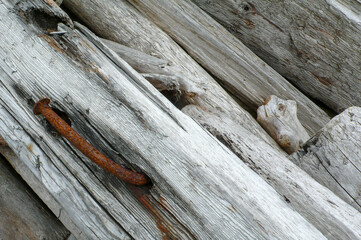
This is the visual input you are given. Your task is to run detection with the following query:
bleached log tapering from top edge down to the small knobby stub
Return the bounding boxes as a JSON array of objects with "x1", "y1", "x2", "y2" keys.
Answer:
[{"x1": 63, "y1": 0, "x2": 286, "y2": 148}]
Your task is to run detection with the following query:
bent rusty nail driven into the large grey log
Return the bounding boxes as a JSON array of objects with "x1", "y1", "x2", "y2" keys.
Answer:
[{"x1": 33, "y1": 98, "x2": 150, "y2": 186}]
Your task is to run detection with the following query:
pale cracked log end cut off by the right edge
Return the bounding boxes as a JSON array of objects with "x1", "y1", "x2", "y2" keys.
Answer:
[{"x1": 290, "y1": 107, "x2": 361, "y2": 211}]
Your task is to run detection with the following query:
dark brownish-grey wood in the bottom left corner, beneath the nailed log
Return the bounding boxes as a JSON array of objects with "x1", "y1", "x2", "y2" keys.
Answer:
[{"x1": 0, "y1": 150, "x2": 70, "y2": 240}]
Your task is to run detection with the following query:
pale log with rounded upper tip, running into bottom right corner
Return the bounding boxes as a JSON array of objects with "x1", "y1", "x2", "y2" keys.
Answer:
[{"x1": 182, "y1": 105, "x2": 361, "y2": 240}]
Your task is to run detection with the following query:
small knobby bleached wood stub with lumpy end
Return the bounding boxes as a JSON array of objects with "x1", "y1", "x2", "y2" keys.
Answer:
[{"x1": 257, "y1": 95, "x2": 310, "y2": 154}]
